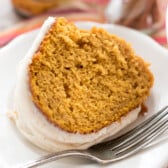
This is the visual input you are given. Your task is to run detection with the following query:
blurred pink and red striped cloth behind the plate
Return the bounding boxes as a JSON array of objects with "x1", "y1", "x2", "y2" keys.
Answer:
[{"x1": 0, "y1": 0, "x2": 168, "y2": 47}]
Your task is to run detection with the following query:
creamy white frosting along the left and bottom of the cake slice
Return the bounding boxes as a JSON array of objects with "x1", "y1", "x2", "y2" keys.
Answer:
[{"x1": 12, "y1": 17, "x2": 140, "y2": 152}]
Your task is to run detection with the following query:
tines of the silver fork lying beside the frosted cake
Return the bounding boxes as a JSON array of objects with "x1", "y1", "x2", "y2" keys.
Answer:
[{"x1": 93, "y1": 106, "x2": 168, "y2": 159}]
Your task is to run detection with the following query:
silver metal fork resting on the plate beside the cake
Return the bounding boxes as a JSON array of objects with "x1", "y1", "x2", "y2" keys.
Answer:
[{"x1": 17, "y1": 106, "x2": 168, "y2": 168}]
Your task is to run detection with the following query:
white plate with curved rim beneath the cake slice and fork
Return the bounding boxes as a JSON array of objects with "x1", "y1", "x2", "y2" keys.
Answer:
[{"x1": 0, "y1": 22, "x2": 168, "y2": 168}]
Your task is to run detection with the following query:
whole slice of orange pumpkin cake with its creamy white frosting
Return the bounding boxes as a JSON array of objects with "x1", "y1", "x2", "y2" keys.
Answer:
[{"x1": 13, "y1": 17, "x2": 153, "y2": 151}]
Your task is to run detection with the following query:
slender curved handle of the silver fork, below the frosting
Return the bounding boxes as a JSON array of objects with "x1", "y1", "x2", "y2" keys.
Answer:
[{"x1": 16, "y1": 150, "x2": 90, "y2": 168}]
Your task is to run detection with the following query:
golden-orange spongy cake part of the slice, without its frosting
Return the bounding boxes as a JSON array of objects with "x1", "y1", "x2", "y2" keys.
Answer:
[{"x1": 29, "y1": 18, "x2": 153, "y2": 134}]
